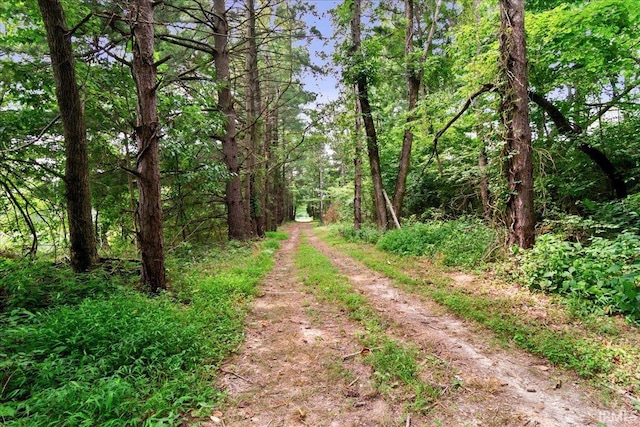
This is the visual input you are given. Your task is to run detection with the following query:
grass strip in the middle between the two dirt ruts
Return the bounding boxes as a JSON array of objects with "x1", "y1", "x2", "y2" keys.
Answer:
[{"x1": 295, "y1": 236, "x2": 449, "y2": 413}]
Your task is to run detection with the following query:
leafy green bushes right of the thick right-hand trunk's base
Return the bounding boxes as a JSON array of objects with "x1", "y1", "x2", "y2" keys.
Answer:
[{"x1": 522, "y1": 233, "x2": 640, "y2": 321}]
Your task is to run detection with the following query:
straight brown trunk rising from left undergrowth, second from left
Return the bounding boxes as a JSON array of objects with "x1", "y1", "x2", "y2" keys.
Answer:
[{"x1": 130, "y1": 0, "x2": 167, "y2": 293}]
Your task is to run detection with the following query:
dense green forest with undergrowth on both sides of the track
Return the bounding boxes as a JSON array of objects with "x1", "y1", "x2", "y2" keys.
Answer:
[{"x1": 0, "y1": 0, "x2": 640, "y2": 425}]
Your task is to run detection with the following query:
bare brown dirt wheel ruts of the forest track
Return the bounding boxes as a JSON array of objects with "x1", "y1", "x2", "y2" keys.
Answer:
[{"x1": 209, "y1": 224, "x2": 640, "y2": 427}]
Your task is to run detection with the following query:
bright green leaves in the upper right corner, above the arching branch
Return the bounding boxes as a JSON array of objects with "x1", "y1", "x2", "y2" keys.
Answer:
[{"x1": 527, "y1": 0, "x2": 638, "y2": 93}]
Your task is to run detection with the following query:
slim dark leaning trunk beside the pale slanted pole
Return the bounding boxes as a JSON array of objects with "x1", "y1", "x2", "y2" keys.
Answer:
[{"x1": 351, "y1": 0, "x2": 387, "y2": 229}]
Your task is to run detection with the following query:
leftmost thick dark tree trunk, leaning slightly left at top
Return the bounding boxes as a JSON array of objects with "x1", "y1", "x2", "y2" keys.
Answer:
[{"x1": 38, "y1": 0, "x2": 98, "y2": 272}]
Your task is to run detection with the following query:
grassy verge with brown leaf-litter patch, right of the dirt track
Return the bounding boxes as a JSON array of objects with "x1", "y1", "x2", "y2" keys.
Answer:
[{"x1": 314, "y1": 227, "x2": 640, "y2": 404}]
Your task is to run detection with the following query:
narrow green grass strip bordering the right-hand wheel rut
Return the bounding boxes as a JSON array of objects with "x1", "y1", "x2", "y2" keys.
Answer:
[{"x1": 317, "y1": 230, "x2": 640, "y2": 392}]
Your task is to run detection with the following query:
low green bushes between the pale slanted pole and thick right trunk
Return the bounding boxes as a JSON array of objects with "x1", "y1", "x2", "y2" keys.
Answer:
[{"x1": 378, "y1": 219, "x2": 497, "y2": 267}]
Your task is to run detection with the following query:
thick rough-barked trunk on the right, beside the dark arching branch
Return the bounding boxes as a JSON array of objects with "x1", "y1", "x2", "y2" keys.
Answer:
[{"x1": 500, "y1": 0, "x2": 535, "y2": 249}]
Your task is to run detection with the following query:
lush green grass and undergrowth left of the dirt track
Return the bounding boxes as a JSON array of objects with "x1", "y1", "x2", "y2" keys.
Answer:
[{"x1": 0, "y1": 239, "x2": 280, "y2": 427}]
